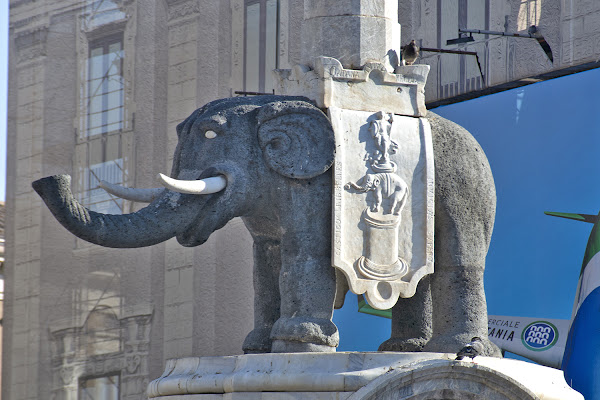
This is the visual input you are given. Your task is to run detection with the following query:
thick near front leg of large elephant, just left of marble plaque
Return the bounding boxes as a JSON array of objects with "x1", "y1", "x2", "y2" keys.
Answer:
[{"x1": 271, "y1": 182, "x2": 339, "y2": 352}]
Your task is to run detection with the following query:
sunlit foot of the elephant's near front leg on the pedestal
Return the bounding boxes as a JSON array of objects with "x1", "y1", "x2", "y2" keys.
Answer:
[{"x1": 271, "y1": 317, "x2": 340, "y2": 353}]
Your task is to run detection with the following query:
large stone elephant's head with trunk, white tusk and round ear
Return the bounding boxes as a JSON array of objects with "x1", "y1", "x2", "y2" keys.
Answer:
[{"x1": 33, "y1": 96, "x2": 335, "y2": 247}]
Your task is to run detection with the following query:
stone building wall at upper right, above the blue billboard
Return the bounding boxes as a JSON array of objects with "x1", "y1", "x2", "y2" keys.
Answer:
[{"x1": 399, "y1": 0, "x2": 600, "y2": 107}]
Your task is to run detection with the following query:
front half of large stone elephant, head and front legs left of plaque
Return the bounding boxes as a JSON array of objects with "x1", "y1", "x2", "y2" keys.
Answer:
[{"x1": 33, "y1": 96, "x2": 339, "y2": 352}]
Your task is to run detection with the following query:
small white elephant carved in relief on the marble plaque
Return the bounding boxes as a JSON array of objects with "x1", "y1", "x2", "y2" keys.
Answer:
[{"x1": 345, "y1": 172, "x2": 408, "y2": 215}]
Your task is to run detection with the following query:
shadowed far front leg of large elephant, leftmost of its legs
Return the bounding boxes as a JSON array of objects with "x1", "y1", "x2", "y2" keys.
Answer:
[{"x1": 242, "y1": 237, "x2": 281, "y2": 354}]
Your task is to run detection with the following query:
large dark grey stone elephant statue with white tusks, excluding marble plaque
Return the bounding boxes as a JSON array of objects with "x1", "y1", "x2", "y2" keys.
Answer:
[{"x1": 33, "y1": 95, "x2": 502, "y2": 353}]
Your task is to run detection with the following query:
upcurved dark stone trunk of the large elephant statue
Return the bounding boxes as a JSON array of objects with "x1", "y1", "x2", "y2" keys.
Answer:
[{"x1": 32, "y1": 175, "x2": 199, "y2": 248}]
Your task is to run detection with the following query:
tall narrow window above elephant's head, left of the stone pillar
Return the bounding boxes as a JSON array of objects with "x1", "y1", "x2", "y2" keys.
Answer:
[{"x1": 244, "y1": 0, "x2": 279, "y2": 93}]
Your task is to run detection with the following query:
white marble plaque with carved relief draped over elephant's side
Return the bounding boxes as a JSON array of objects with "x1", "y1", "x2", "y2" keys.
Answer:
[{"x1": 329, "y1": 107, "x2": 434, "y2": 309}]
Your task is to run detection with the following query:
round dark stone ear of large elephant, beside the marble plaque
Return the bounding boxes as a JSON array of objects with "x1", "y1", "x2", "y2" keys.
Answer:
[{"x1": 257, "y1": 101, "x2": 335, "y2": 179}]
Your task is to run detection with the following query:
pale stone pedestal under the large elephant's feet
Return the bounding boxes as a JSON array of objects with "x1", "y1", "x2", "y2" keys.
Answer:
[{"x1": 148, "y1": 352, "x2": 583, "y2": 400}]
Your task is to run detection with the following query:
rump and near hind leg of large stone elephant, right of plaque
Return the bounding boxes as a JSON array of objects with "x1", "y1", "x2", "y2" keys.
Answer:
[{"x1": 424, "y1": 113, "x2": 500, "y2": 355}]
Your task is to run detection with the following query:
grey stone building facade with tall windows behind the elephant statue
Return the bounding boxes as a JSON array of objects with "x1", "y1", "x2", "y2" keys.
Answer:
[{"x1": 2, "y1": 0, "x2": 600, "y2": 400}]
